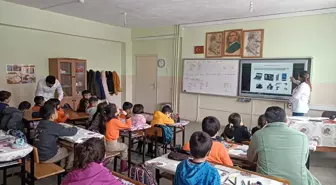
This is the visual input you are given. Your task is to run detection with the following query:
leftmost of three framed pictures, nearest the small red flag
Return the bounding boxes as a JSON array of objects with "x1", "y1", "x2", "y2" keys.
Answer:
[{"x1": 205, "y1": 32, "x2": 223, "y2": 58}]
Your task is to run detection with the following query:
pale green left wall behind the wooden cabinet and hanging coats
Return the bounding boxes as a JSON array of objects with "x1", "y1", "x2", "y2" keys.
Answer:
[{"x1": 0, "y1": 1, "x2": 133, "y2": 106}]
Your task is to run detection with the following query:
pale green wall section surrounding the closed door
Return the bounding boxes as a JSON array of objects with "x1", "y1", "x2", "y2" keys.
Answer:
[{"x1": 132, "y1": 26, "x2": 174, "y2": 104}]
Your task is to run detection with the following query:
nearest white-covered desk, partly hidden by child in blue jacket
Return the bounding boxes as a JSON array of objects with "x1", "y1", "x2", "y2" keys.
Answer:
[{"x1": 146, "y1": 154, "x2": 289, "y2": 185}]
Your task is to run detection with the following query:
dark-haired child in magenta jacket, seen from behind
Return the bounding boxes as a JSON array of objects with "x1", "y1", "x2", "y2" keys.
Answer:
[{"x1": 62, "y1": 138, "x2": 122, "y2": 185}]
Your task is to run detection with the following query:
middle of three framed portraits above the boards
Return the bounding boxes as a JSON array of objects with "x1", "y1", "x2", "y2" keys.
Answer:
[{"x1": 223, "y1": 29, "x2": 243, "y2": 57}]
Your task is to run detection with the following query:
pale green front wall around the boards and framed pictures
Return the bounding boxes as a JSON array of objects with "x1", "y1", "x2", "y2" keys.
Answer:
[{"x1": 180, "y1": 13, "x2": 336, "y2": 127}]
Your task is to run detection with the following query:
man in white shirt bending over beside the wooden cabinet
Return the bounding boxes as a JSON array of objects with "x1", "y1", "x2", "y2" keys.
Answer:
[{"x1": 35, "y1": 75, "x2": 64, "y2": 101}]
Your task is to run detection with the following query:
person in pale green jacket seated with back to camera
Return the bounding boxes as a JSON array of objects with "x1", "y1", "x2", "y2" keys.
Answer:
[{"x1": 247, "y1": 106, "x2": 321, "y2": 185}]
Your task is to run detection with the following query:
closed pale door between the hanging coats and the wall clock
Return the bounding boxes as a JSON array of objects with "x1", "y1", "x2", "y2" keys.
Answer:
[{"x1": 135, "y1": 56, "x2": 157, "y2": 113}]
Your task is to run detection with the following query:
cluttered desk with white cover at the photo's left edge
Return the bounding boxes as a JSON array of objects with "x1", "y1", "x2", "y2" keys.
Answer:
[{"x1": 0, "y1": 130, "x2": 33, "y2": 185}]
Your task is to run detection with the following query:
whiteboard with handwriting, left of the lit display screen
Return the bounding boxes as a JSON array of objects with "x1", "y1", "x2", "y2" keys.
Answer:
[{"x1": 182, "y1": 59, "x2": 239, "y2": 96}]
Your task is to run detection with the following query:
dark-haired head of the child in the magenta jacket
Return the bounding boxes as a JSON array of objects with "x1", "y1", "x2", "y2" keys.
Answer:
[{"x1": 73, "y1": 138, "x2": 105, "y2": 169}]
